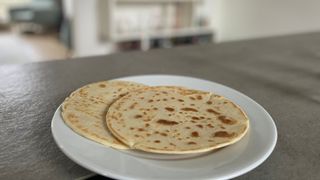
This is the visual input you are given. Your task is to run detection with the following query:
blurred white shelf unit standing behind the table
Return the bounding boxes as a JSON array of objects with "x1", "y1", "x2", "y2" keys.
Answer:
[{"x1": 98, "y1": 0, "x2": 213, "y2": 51}]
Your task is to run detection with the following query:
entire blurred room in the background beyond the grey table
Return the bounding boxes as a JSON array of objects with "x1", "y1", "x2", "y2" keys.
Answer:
[{"x1": 0, "y1": 0, "x2": 320, "y2": 65}]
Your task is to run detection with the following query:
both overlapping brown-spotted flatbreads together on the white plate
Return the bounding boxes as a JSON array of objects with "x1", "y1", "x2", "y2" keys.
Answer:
[{"x1": 61, "y1": 80, "x2": 249, "y2": 154}]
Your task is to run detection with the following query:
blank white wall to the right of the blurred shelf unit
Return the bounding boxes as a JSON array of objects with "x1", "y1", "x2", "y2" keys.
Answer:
[{"x1": 213, "y1": 0, "x2": 320, "y2": 42}]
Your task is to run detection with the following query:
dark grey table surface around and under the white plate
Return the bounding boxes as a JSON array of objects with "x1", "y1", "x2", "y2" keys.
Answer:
[{"x1": 0, "y1": 33, "x2": 320, "y2": 179}]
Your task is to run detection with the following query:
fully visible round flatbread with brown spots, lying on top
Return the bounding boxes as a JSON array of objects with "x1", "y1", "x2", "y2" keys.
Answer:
[{"x1": 106, "y1": 87, "x2": 249, "y2": 154}]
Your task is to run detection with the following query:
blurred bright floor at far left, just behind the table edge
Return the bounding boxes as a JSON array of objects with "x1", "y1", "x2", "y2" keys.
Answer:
[{"x1": 0, "y1": 31, "x2": 69, "y2": 65}]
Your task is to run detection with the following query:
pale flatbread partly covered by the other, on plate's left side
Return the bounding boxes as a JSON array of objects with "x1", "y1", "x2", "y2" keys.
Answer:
[{"x1": 61, "y1": 81, "x2": 145, "y2": 149}]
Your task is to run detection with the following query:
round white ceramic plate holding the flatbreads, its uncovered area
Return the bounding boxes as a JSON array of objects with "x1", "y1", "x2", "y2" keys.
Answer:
[{"x1": 51, "y1": 75, "x2": 277, "y2": 180}]
